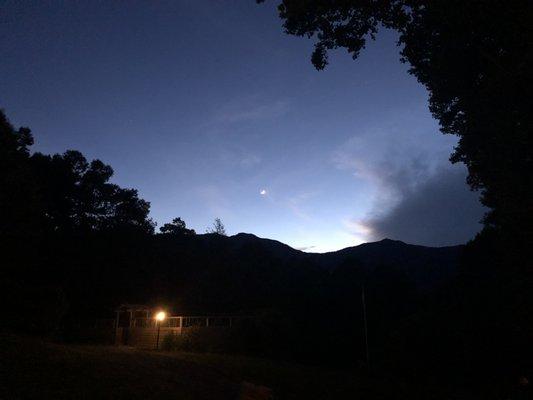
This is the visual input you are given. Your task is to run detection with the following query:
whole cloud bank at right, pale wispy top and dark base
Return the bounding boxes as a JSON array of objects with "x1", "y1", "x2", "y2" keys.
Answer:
[{"x1": 331, "y1": 123, "x2": 483, "y2": 245}]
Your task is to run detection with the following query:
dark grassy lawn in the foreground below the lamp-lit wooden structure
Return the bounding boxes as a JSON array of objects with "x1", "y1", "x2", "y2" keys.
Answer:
[{"x1": 0, "y1": 335, "x2": 365, "y2": 399}]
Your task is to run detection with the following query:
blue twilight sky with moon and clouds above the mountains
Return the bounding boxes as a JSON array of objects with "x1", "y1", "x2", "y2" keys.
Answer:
[{"x1": 0, "y1": 0, "x2": 483, "y2": 252}]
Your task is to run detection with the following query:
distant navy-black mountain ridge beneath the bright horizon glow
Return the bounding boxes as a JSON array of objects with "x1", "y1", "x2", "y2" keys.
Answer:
[{"x1": 176, "y1": 233, "x2": 464, "y2": 289}]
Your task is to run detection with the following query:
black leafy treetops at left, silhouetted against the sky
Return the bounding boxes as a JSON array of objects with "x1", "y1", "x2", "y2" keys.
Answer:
[{"x1": 0, "y1": 108, "x2": 154, "y2": 234}]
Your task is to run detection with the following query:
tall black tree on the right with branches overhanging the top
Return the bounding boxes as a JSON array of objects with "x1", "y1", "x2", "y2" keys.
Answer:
[{"x1": 258, "y1": 0, "x2": 533, "y2": 241}]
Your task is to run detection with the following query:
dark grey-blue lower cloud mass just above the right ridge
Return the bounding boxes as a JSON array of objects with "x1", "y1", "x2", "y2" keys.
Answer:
[{"x1": 364, "y1": 165, "x2": 485, "y2": 246}]
